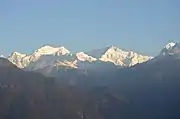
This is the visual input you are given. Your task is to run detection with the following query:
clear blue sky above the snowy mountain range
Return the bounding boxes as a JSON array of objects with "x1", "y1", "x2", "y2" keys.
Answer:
[{"x1": 0, "y1": 0, "x2": 180, "y2": 55}]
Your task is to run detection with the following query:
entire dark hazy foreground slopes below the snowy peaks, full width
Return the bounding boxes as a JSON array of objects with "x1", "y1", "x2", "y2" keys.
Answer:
[{"x1": 0, "y1": 56, "x2": 180, "y2": 119}]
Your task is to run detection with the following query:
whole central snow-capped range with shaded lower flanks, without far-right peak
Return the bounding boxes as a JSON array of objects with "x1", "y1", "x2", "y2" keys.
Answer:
[{"x1": 8, "y1": 45, "x2": 152, "y2": 74}]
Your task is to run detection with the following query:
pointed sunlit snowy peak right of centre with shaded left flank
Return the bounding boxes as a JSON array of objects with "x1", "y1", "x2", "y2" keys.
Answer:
[{"x1": 88, "y1": 46, "x2": 152, "y2": 67}]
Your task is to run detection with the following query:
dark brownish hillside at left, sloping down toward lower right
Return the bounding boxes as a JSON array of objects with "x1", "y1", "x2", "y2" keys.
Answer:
[{"x1": 0, "y1": 59, "x2": 129, "y2": 119}]
